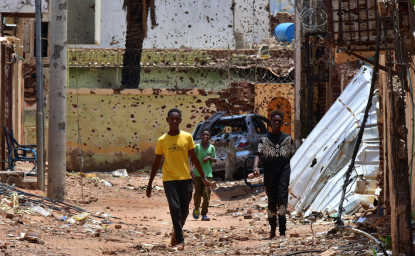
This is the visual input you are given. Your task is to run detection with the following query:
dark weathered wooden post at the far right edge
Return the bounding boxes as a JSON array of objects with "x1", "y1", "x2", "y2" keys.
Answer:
[{"x1": 385, "y1": 43, "x2": 413, "y2": 256}]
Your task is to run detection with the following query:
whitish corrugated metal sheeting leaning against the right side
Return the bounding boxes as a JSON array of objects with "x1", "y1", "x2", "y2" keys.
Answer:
[{"x1": 288, "y1": 67, "x2": 379, "y2": 216}]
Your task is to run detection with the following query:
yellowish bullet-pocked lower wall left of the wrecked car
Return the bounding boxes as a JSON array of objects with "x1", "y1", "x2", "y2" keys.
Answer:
[{"x1": 67, "y1": 89, "x2": 219, "y2": 172}]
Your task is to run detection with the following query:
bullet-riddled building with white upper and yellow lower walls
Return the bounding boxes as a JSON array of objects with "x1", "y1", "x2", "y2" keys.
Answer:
[{"x1": 0, "y1": 0, "x2": 298, "y2": 172}]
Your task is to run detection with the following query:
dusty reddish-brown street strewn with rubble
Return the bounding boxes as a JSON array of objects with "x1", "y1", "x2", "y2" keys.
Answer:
[{"x1": 0, "y1": 169, "x2": 386, "y2": 255}]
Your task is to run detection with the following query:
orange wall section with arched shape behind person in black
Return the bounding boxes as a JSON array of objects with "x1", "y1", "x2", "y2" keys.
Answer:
[{"x1": 255, "y1": 84, "x2": 295, "y2": 138}]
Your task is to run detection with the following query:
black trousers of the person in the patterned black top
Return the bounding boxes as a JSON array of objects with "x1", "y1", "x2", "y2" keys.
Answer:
[{"x1": 265, "y1": 186, "x2": 287, "y2": 235}]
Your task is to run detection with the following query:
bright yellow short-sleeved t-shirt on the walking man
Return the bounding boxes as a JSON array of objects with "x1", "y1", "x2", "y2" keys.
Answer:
[{"x1": 156, "y1": 131, "x2": 195, "y2": 181}]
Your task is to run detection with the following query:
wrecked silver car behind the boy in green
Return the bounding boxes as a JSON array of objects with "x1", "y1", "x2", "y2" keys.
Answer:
[{"x1": 192, "y1": 111, "x2": 271, "y2": 172}]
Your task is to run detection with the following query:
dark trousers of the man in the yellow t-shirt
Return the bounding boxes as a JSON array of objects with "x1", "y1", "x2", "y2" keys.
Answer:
[{"x1": 163, "y1": 180, "x2": 193, "y2": 243}]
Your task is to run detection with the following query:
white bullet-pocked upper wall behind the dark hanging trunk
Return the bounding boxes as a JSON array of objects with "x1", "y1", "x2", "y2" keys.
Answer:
[{"x1": 72, "y1": 0, "x2": 269, "y2": 49}]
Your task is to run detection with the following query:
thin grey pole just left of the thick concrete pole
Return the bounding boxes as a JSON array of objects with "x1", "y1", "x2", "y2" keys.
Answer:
[{"x1": 35, "y1": 0, "x2": 45, "y2": 191}]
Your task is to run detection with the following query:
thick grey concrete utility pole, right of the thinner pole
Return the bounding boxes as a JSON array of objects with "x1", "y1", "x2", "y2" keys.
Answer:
[{"x1": 48, "y1": 0, "x2": 67, "y2": 200}]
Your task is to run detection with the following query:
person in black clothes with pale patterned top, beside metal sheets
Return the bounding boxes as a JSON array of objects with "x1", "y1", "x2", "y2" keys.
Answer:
[{"x1": 253, "y1": 110, "x2": 294, "y2": 239}]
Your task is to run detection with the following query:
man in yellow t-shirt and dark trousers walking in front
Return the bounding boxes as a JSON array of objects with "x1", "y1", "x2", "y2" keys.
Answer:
[{"x1": 146, "y1": 108, "x2": 210, "y2": 250}]
